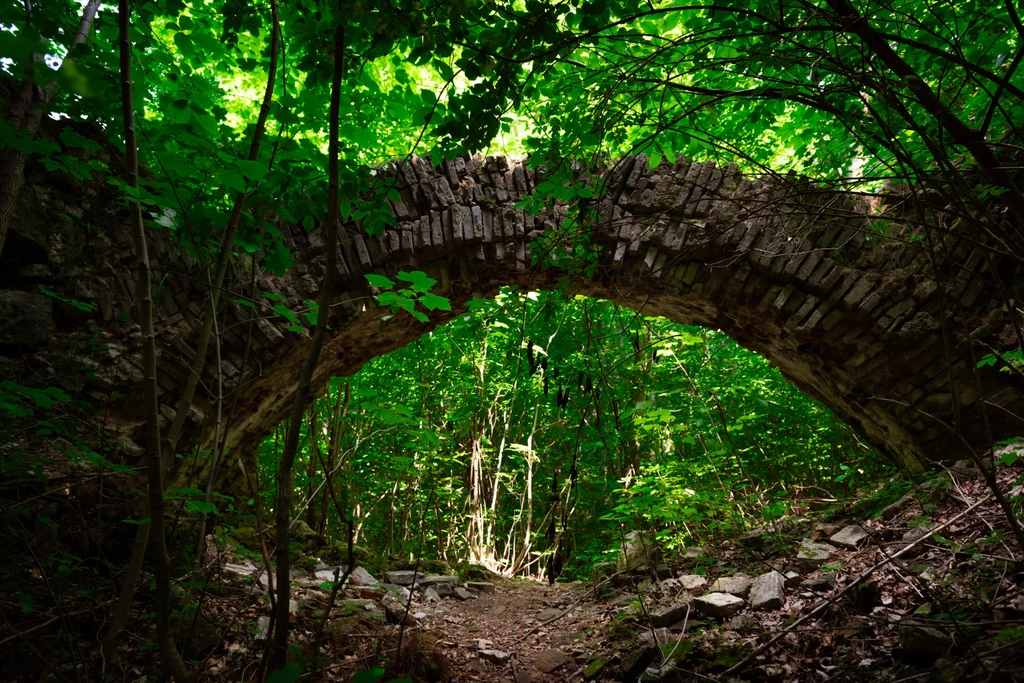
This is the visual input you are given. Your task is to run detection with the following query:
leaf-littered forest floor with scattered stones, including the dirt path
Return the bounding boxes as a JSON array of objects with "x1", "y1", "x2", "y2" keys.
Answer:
[{"x1": 0, "y1": 450, "x2": 1024, "y2": 683}]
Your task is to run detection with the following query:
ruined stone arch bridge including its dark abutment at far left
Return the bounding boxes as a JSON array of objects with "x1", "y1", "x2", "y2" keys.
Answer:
[{"x1": 0, "y1": 148, "x2": 1024, "y2": 485}]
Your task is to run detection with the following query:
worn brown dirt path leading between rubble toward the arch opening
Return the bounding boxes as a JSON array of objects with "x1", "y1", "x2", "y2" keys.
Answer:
[{"x1": 425, "y1": 581, "x2": 607, "y2": 683}]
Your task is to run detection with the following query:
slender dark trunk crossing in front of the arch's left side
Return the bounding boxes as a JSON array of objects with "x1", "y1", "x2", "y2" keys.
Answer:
[{"x1": 267, "y1": 24, "x2": 345, "y2": 672}]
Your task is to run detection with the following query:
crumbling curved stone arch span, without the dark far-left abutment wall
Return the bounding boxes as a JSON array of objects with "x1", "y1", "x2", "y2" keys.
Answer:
[{"x1": 153, "y1": 156, "x2": 1024, "y2": 485}]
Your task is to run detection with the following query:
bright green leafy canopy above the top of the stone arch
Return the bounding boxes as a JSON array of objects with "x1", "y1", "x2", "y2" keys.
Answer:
[{"x1": 0, "y1": 0, "x2": 1024, "y2": 259}]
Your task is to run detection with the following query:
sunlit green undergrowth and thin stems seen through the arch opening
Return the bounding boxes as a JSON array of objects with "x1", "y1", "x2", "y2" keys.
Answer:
[{"x1": 258, "y1": 291, "x2": 888, "y2": 578}]
